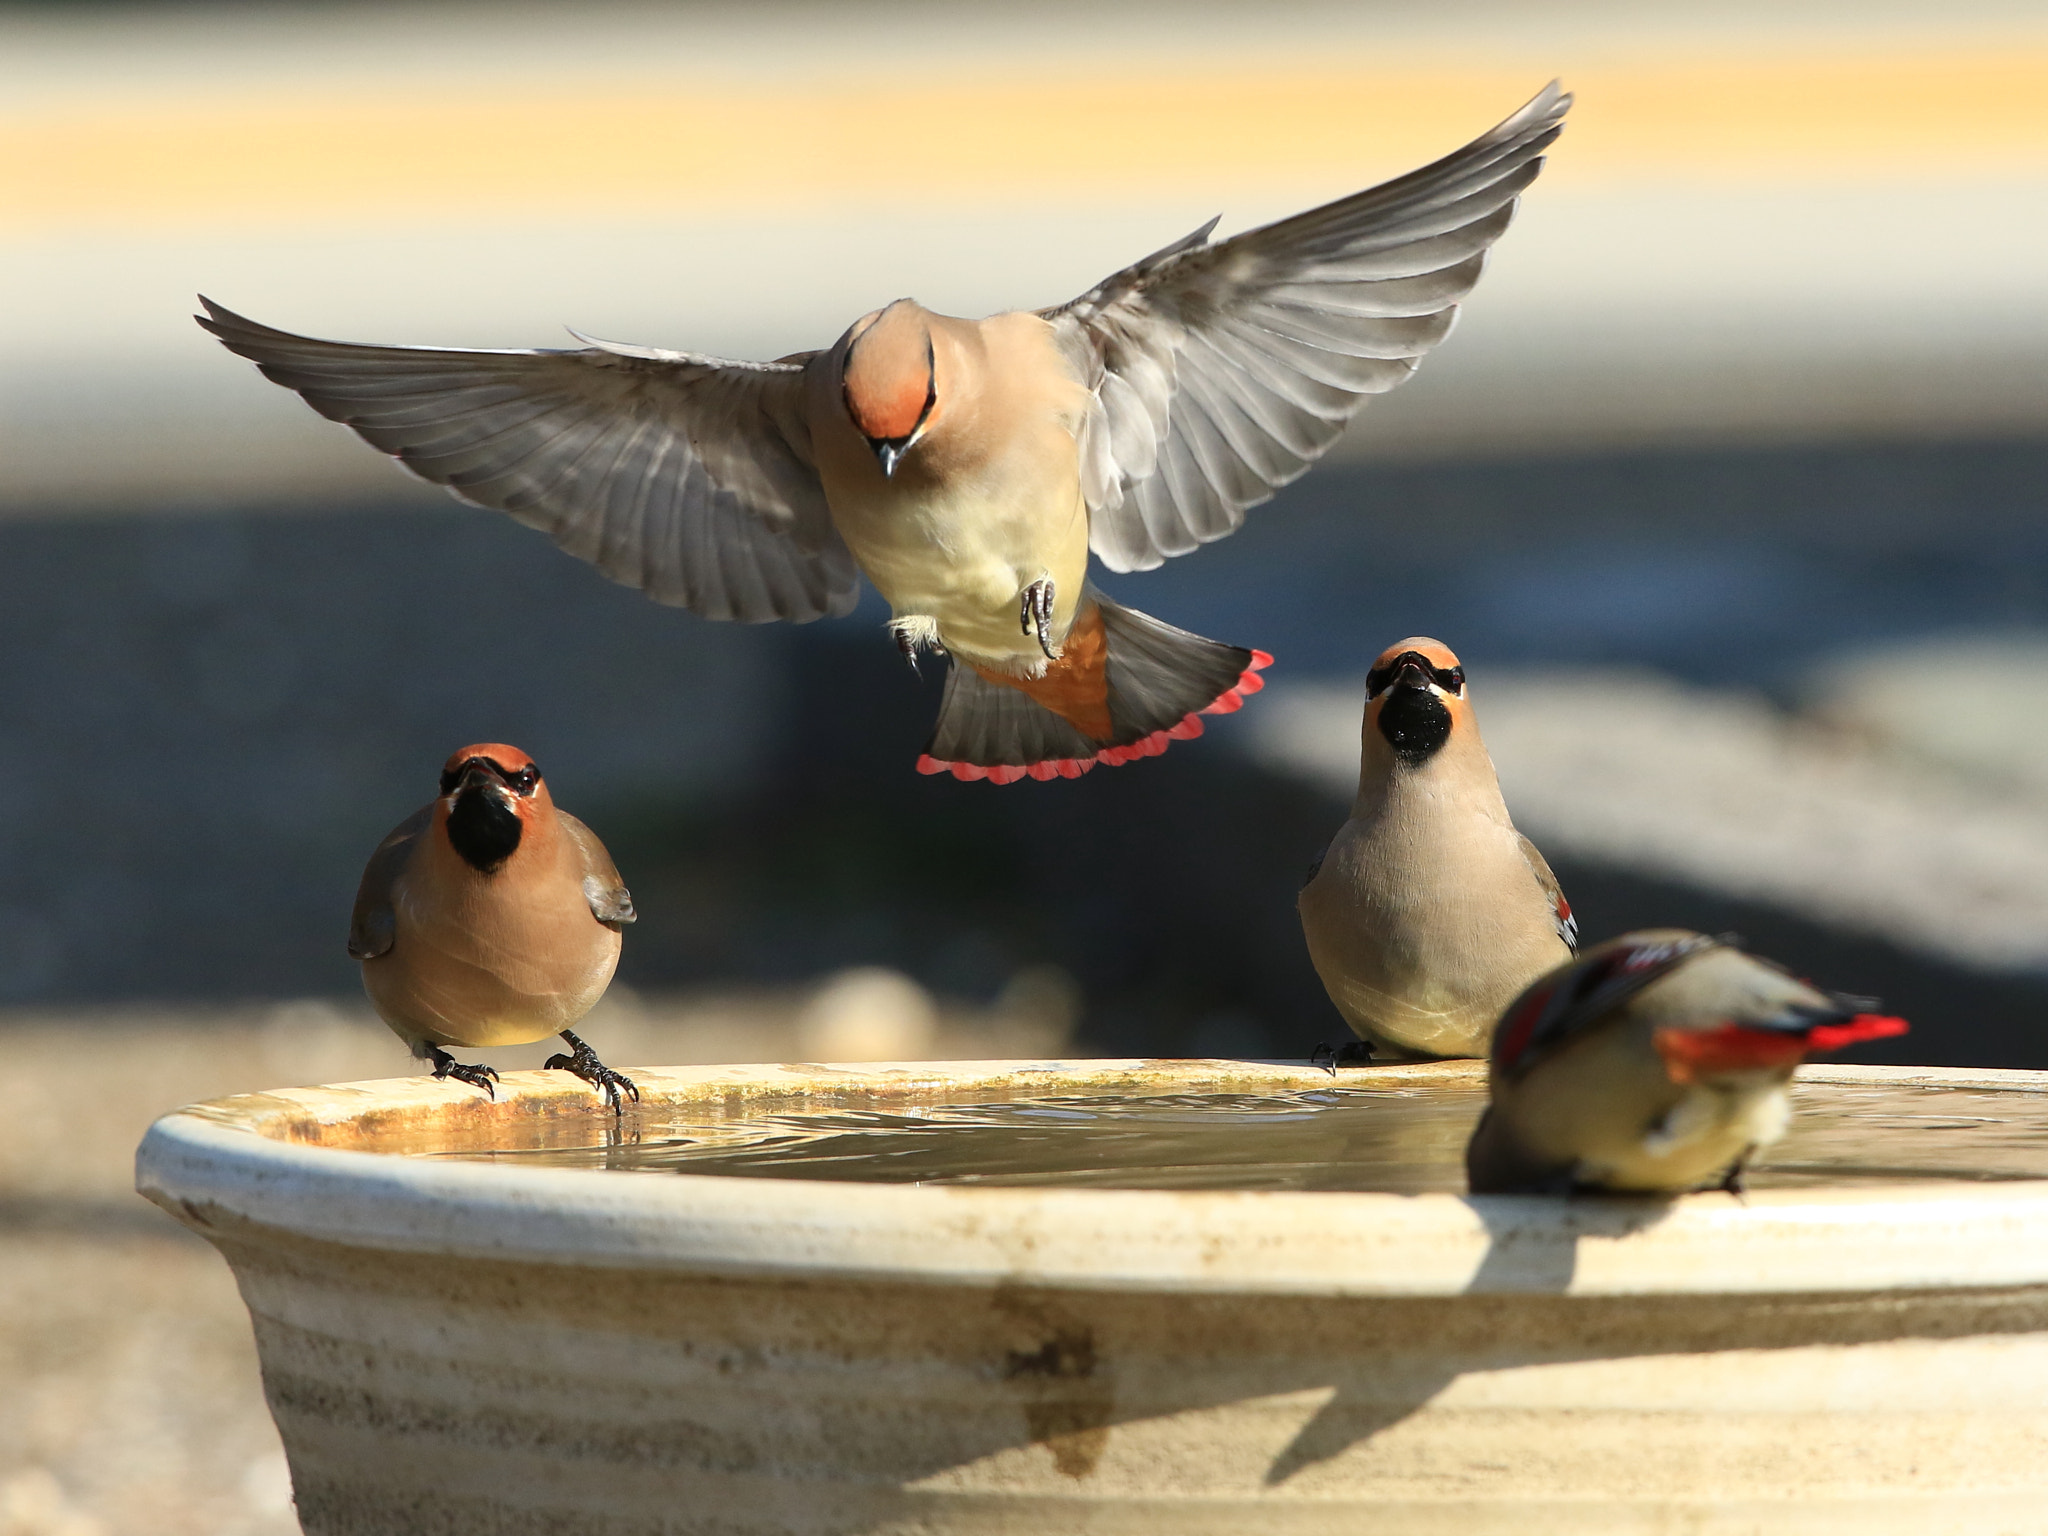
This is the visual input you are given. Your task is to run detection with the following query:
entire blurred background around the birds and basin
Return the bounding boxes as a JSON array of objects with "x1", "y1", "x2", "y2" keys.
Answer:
[{"x1": 0, "y1": 0, "x2": 2048, "y2": 1536}]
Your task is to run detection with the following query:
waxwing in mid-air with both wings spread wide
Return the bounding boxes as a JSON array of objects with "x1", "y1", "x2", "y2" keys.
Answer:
[{"x1": 199, "y1": 84, "x2": 1571, "y2": 784}]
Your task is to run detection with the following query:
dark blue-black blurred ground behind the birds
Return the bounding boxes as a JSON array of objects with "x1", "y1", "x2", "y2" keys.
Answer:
[{"x1": 12, "y1": 442, "x2": 2048, "y2": 1065}]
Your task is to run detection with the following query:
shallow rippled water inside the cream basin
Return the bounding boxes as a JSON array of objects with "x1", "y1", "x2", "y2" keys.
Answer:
[{"x1": 395, "y1": 1083, "x2": 2048, "y2": 1194}]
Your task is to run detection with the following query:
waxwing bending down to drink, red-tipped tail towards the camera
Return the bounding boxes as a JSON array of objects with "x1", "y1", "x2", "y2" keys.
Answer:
[{"x1": 1464, "y1": 928, "x2": 1907, "y2": 1194}]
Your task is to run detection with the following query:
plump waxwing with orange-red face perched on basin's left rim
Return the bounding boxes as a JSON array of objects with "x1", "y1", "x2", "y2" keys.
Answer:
[{"x1": 348, "y1": 741, "x2": 639, "y2": 1114}]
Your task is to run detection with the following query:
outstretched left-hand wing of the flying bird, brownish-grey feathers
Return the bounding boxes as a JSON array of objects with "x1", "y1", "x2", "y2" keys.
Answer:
[{"x1": 199, "y1": 299, "x2": 858, "y2": 623}]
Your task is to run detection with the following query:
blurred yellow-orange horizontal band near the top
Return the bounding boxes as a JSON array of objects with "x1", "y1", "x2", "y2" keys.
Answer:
[{"x1": 0, "y1": 43, "x2": 2048, "y2": 233}]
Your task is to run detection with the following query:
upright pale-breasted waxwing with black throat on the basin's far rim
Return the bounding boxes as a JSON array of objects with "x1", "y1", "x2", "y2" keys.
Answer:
[{"x1": 1298, "y1": 635, "x2": 1579, "y2": 1065}]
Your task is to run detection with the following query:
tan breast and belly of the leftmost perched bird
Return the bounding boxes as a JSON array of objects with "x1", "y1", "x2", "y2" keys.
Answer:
[{"x1": 362, "y1": 838, "x2": 618, "y2": 1047}]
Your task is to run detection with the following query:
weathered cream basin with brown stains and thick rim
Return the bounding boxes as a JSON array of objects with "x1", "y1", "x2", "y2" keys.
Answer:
[{"x1": 137, "y1": 1061, "x2": 2048, "y2": 1536}]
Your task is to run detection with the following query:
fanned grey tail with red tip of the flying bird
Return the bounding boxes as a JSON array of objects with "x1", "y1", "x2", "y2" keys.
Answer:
[{"x1": 918, "y1": 590, "x2": 1272, "y2": 784}]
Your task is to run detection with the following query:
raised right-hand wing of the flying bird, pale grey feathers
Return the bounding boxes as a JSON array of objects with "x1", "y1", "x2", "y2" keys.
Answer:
[{"x1": 1044, "y1": 82, "x2": 1571, "y2": 571}]
